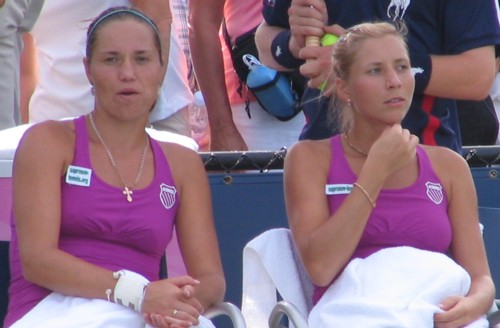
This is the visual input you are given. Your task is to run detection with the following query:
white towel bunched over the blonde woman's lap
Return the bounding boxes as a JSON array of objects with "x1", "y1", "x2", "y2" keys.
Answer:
[{"x1": 309, "y1": 247, "x2": 488, "y2": 328}]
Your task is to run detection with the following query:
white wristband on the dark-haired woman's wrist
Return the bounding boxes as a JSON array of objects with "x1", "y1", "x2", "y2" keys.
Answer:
[{"x1": 113, "y1": 270, "x2": 149, "y2": 312}]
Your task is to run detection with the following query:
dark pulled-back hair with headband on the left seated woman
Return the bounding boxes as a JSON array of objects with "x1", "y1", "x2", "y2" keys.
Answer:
[{"x1": 85, "y1": 6, "x2": 163, "y2": 65}]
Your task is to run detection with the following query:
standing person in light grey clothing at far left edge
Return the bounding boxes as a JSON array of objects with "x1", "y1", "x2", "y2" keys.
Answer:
[{"x1": 0, "y1": 0, "x2": 44, "y2": 130}]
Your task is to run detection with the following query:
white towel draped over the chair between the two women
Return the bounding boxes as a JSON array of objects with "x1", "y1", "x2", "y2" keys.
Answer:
[{"x1": 242, "y1": 228, "x2": 312, "y2": 328}]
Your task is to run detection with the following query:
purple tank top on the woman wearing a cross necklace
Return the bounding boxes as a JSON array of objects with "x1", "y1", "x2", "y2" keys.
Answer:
[{"x1": 5, "y1": 116, "x2": 179, "y2": 326}]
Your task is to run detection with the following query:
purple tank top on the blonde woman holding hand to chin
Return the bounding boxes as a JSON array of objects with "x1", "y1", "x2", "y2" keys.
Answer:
[{"x1": 313, "y1": 136, "x2": 451, "y2": 303}]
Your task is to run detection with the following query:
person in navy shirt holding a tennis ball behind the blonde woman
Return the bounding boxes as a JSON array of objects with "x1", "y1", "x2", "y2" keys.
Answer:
[{"x1": 256, "y1": 0, "x2": 500, "y2": 153}]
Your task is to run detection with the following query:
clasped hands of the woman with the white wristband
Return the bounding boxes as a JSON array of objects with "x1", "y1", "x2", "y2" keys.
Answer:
[{"x1": 142, "y1": 276, "x2": 203, "y2": 328}]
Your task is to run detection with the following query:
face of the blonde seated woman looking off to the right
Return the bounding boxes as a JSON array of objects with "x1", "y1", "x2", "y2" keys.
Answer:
[{"x1": 337, "y1": 35, "x2": 415, "y2": 141}]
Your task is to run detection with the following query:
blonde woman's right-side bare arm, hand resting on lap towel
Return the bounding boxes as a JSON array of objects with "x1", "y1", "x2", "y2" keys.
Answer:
[{"x1": 429, "y1": 148, "x2": 495, "y2": 327}]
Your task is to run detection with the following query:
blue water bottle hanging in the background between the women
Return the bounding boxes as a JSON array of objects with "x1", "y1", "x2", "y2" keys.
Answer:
[{"x1": 243, "y1": 54, "x2": 299, "y2": 121}]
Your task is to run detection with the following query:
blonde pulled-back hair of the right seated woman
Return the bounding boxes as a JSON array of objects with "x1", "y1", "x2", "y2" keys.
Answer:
[{"x1": 332, "y1": 21, "x2": 408, "y2": 132}]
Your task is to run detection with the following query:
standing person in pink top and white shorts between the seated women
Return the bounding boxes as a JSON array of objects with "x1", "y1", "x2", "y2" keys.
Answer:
[{"x1": 189, "y1": 0, "x2": 305, "y2": 151}]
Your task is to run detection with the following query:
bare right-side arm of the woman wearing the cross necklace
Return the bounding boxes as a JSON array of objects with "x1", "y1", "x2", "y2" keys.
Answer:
[{"x1": 167, "y1": 145, "x2": 225, "y2": 309}]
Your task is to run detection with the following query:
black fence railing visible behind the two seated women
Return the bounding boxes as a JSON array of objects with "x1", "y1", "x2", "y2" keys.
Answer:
[{"x1": 200, "y1": 146, "x2": 500, "y2": 173}]
